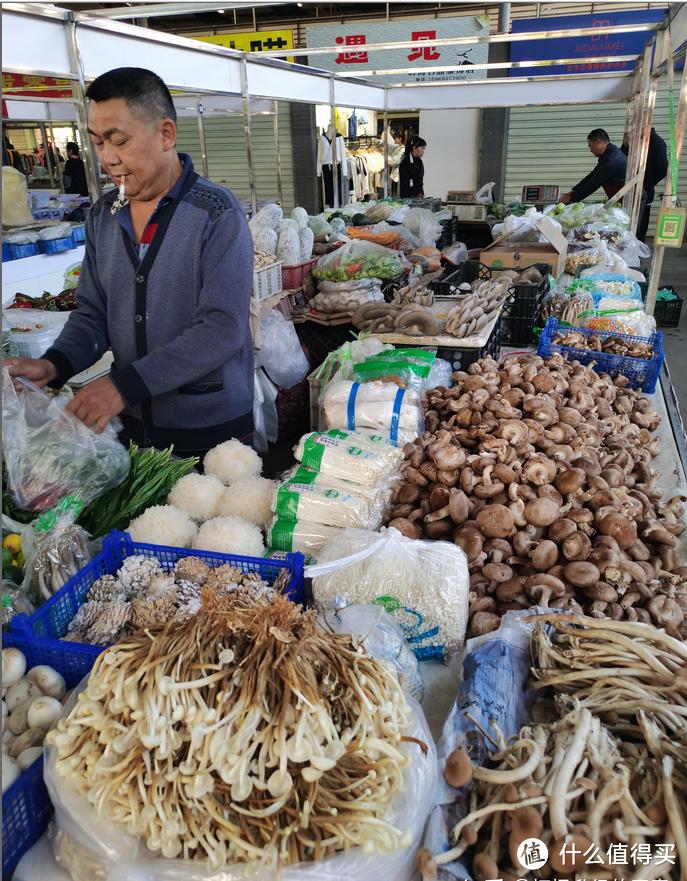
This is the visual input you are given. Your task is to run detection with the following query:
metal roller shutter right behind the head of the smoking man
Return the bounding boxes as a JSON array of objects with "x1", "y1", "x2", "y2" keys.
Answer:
[{"x1": 177, "y1": 102, "x2": 295, "y2": 216}]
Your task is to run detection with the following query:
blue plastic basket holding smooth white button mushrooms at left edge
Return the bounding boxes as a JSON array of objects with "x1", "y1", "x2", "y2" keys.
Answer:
[{"x1": 2, "y1": 633, "x2": 97, "y2": 878}]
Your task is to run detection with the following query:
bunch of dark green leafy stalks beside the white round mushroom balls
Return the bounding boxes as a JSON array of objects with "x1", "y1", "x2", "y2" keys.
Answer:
[{"x1": 78, "y1": 443, "x2": 199, "y2": 538}]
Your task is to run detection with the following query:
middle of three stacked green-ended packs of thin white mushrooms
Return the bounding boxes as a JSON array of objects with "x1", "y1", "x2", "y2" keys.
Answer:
[{"x1": 272, "y1": 471, "x2": 383, "y2": 529}]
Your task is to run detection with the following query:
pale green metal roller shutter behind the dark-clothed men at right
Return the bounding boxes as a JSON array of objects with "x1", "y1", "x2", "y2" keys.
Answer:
[{"x1": 504, "y1": 72, "x2": 687, "y2": 235}]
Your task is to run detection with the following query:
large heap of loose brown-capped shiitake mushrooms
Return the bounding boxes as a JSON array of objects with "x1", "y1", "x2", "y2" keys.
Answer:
[{"x1": 388, "y1": 355, "x2": 687, "y2": 638}]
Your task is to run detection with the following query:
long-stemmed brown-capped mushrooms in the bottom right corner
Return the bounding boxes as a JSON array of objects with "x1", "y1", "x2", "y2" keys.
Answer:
[{"x1": 418, "y1": 709, "x2": 687, "y2": 881}]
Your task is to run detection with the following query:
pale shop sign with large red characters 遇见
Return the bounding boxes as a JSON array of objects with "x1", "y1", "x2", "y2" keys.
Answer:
[{"x1": 306, "y1": 15, "x2": 489, "y2": 83}]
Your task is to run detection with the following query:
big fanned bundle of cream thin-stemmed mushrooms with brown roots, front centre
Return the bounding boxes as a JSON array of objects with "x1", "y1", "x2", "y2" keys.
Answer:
[{"x1": 49, "y1": 588, "x2": 426, "y2": 871}]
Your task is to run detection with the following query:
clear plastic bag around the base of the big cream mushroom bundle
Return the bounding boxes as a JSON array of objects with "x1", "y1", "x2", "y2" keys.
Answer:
[{"x1": 44, "y1": 680, "x2": 437, "y2": 881}]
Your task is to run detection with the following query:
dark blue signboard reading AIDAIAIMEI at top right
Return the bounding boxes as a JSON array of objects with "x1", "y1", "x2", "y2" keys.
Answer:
[{"x1": 510, "y1": 9, "x2": 666, "y2": 76}]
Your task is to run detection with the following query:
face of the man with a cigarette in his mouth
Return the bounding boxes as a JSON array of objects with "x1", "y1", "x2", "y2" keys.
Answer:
[{"x1": 88, "y1": 98, "x2": 176, "y2": 201}]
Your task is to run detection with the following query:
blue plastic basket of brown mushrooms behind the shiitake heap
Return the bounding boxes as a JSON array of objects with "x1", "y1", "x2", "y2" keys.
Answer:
[{"x1": 537, "y1": 318, "x2": 665, "y2": 395}]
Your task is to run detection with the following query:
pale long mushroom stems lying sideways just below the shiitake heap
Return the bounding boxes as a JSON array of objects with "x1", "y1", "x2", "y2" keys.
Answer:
[{"x1": 530, "y1": 614, "x2": 687, "y2": 768}]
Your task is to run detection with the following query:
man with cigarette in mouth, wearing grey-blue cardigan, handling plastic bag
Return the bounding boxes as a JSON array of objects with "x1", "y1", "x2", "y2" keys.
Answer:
[{"x1": 4, "y1": 68, "x2": 253, "y2": 456}]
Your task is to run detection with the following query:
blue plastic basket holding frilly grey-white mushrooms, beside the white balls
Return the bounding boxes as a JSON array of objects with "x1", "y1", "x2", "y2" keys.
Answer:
[{"x1": 12, "y1": 529, "x2": 305, "y2": 663}]
